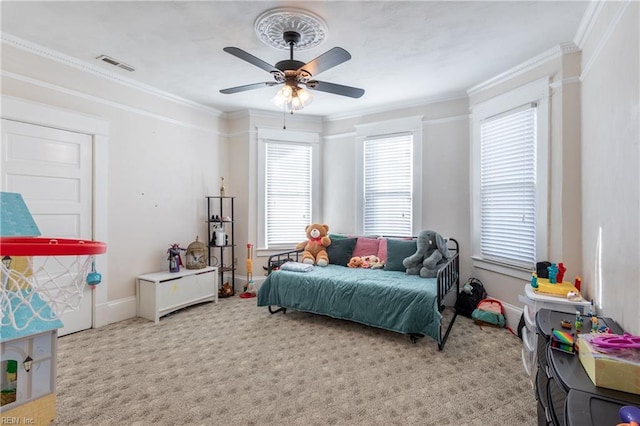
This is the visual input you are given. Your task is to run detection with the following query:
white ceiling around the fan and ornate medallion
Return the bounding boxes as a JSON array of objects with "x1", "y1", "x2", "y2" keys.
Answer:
[{"x1": 0, "y1": 0, "x2": 588, "y2": 116}]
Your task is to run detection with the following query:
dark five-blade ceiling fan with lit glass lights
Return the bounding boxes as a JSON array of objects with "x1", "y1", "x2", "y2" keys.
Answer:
[{"x1": 220, "y1": 31, "x2": 364, "y2": 110}]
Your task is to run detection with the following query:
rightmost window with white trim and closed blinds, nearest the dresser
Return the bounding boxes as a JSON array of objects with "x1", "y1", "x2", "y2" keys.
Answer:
[{"x1": 472, "y1": 79, "x2": 548, "y2": 276}]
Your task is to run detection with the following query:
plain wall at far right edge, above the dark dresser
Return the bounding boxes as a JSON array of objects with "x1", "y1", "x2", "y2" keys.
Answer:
[{"x1": 581, "y1": 2, "x2": 640, "y2": 335}]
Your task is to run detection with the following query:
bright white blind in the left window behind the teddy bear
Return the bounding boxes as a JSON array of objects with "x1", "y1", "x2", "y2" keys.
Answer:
[{"x1": 265, "y1": 141, "x2": 312, "y2": 246}]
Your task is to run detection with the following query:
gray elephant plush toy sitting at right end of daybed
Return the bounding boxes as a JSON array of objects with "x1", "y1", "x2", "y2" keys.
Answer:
[{"x1": 402, "y1": 231, "x2": 451, "y2": 278}]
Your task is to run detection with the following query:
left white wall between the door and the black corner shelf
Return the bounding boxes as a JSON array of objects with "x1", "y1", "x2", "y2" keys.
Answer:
[{"x1": 1, "y1": 43, "x2": 226, "y2": 325}]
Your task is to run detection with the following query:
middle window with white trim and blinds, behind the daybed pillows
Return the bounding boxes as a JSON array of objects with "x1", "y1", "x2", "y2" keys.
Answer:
[{"x1": 356, "y1": 117, "x2": 422, "y2": 236}]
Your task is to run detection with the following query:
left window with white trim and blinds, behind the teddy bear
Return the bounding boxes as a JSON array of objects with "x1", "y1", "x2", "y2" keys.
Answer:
[{"x1": 258, "y1": 129, "x2": 319, "y2": 249}]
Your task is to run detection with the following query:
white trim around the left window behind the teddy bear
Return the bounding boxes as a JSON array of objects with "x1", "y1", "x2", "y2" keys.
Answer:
[{"x1": 256, "y1": 127, "x2": 320, "y2": 255}]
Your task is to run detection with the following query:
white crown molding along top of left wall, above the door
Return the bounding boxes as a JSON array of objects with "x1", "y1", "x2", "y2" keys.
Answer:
[{"x1": 0, "y1": 32, "x2": 223, "y2": 117}]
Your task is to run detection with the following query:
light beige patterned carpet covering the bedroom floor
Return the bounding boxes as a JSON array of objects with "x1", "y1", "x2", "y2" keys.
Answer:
[{"x1": 55, "y1": 297, "x2": 536, "y2": 426}]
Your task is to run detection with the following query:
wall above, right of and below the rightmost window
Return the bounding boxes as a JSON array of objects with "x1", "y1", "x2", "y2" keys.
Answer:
[{"x1": 469, "y1": 44, "x2": 582, "y2": 314}]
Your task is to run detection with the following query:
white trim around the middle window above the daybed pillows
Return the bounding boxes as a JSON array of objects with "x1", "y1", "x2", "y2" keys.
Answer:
[{"x1": 354, "y1": 116, "x2": 422, "y2": 234}]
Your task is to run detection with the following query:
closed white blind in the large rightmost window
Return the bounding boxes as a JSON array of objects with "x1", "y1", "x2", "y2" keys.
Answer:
[{"x1": 480, "y1": 104, "x2": 537, "y2": 267}]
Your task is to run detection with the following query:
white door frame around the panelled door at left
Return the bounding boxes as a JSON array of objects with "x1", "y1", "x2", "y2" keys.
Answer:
[{"x1": 0, "y1": 95, "x2": 110, "y2": 328}]
